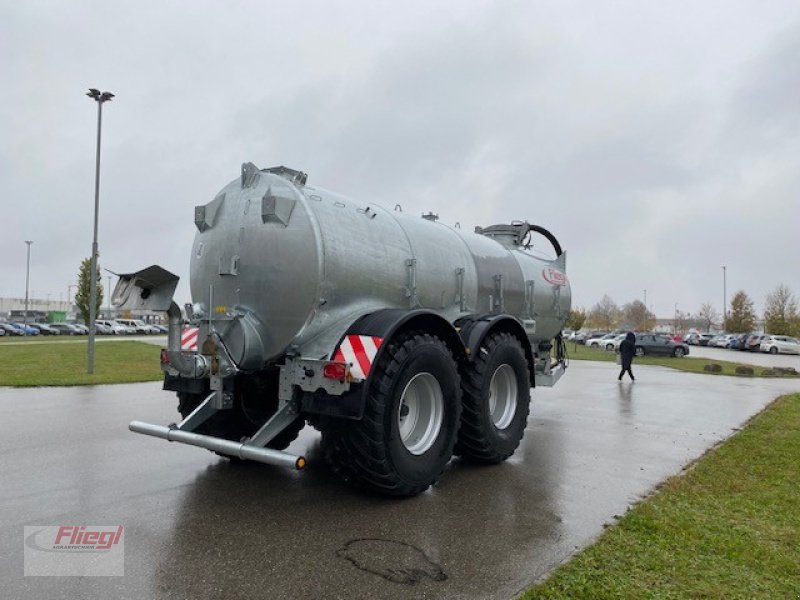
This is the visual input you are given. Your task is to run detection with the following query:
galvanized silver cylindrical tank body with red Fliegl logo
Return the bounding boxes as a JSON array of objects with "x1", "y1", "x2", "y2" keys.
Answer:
[{"x1": 191, "y1": 165, "x2": 571, "y2": 369}]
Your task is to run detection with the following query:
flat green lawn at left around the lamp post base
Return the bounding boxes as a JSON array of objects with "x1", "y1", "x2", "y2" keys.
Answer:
[{"x1": 0, "y1": 338, "x2": 162, "y2": 387}]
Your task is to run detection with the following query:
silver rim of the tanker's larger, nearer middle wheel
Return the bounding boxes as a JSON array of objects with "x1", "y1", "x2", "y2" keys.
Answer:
[{"x1": 397, "y1": 373, "x2": 444, "y2": 456}]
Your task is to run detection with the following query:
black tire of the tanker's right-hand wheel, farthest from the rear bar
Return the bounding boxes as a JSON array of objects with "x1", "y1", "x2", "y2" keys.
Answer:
[{"x1": 455, "y1": 333, "x2": 531, "y2": 464}]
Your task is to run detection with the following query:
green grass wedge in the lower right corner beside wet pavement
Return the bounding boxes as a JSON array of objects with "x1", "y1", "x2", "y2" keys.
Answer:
[{"x1": 523, "y1": 394, "x2": 800, "y2": 600}]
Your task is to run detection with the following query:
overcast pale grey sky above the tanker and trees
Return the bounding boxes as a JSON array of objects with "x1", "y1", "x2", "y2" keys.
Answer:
[{"x1": 0, "y1": 0, "x2": 800, "y2": 316}]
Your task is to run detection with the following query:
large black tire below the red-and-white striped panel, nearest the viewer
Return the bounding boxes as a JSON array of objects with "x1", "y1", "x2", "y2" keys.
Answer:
[{"x1": 323, "y1": 332, "x2": 461, "y2": 497}]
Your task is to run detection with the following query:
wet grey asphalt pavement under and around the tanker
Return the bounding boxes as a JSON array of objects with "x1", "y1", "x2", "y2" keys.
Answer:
[{"x1": 0, "y1": 362, "x2": 800, "y2": 598}]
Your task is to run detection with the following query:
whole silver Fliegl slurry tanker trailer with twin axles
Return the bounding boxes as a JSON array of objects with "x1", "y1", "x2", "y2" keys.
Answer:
[{"x1": 113, "y1": 163, "x2": 571, "y2": 496}]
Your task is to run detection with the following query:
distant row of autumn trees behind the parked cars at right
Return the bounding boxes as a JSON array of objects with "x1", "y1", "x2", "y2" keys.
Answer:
[{"x1": 566, "y1": 284, "x2": 800, "y2": 337}]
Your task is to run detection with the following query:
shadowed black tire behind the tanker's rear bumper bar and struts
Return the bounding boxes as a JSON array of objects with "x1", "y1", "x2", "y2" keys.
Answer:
[{"x1": 178, "y1": 376, "x2": 305, "y2": 450}]
